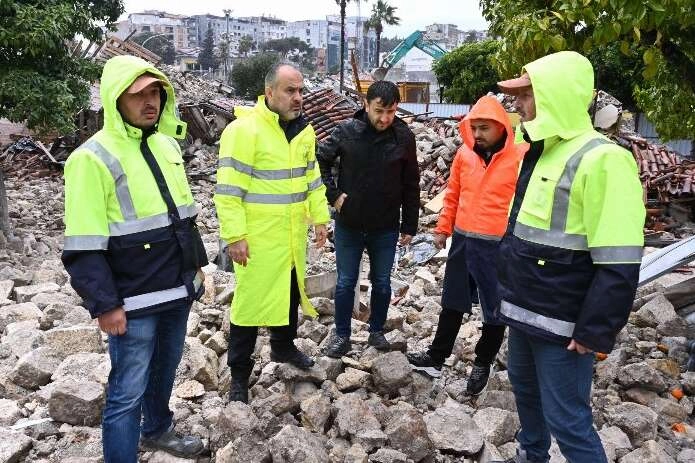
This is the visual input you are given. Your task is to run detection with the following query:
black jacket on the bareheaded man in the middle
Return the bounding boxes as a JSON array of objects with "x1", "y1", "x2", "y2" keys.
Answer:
[{"x1": 316, "y1": 109, "x2": 420, "y2": 235}]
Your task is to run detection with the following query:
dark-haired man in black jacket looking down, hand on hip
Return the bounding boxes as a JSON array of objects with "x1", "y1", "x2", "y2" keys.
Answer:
[{"x1": 317, "y1": 81, "x2": 420, "y2": 357}]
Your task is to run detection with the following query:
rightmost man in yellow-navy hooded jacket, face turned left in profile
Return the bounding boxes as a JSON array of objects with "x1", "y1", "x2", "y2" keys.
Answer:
[{"x1": 498, "y1": 51, "x2": 645, "y2": 463}]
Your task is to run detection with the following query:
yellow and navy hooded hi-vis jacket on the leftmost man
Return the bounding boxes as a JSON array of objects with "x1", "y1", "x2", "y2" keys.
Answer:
[{"x1": 62, "y1": 56, "x2": 207, "y2": 317}]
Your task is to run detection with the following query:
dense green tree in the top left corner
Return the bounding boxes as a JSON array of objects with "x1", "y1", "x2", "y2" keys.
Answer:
[{"x1": 0, "y1": 0, "x2": 123, "y2": 133}]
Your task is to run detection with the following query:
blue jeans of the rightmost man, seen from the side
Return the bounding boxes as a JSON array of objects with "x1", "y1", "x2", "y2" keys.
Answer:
[{"x1": 508, "y1": 327, "x2": 607, "y2": 463}]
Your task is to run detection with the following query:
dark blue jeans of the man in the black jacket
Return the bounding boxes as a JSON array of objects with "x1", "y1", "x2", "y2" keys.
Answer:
[{"x1": 335, "y1": 221, "x2": 398, "y2": 337}]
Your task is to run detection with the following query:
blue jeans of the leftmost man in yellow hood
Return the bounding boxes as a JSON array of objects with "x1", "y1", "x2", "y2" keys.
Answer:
[{"x1": 102, "y1": 302, "x2": 190, "y2": 463}]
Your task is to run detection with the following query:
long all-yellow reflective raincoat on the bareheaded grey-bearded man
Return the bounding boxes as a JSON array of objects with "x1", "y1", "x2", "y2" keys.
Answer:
[{"x1": 214, "y1": 96, "x2": 330, "y2": 326}]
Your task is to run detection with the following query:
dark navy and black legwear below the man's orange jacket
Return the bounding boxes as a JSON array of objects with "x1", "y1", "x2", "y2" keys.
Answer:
[{"x1": 429, "y1": 232, "x2": 505, "y2": 365}]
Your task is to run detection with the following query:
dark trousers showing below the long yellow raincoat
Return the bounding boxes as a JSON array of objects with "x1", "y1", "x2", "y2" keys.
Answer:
[{"x1": 227, "y1": 269, "x2": 300, "y2": 378}]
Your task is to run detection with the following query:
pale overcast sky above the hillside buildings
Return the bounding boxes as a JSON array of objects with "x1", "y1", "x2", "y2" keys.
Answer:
[{"x1": 124, "y1": 0, "x2": 487, "y2": 37}]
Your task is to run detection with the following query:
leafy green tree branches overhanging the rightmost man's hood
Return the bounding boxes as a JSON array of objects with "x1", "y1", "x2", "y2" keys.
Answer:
[{"x1": 480, "y1": 0, "x2": 695, "y2": 139}]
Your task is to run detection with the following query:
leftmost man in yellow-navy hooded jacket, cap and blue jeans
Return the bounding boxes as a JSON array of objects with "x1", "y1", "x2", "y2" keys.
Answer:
[{"x1": 62, "y1": 56, "x2": 207, "y2": 463}]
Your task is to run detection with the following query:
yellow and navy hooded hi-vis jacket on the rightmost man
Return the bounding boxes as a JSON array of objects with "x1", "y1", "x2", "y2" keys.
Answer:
[{"x1": 498, "y1": 51, "x2": 645, "y2": 352}]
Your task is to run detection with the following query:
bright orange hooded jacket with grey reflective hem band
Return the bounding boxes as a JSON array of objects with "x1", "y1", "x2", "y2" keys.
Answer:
[{"x1": 434, "y1": 96, "x2": 528, "y2": 241}]
